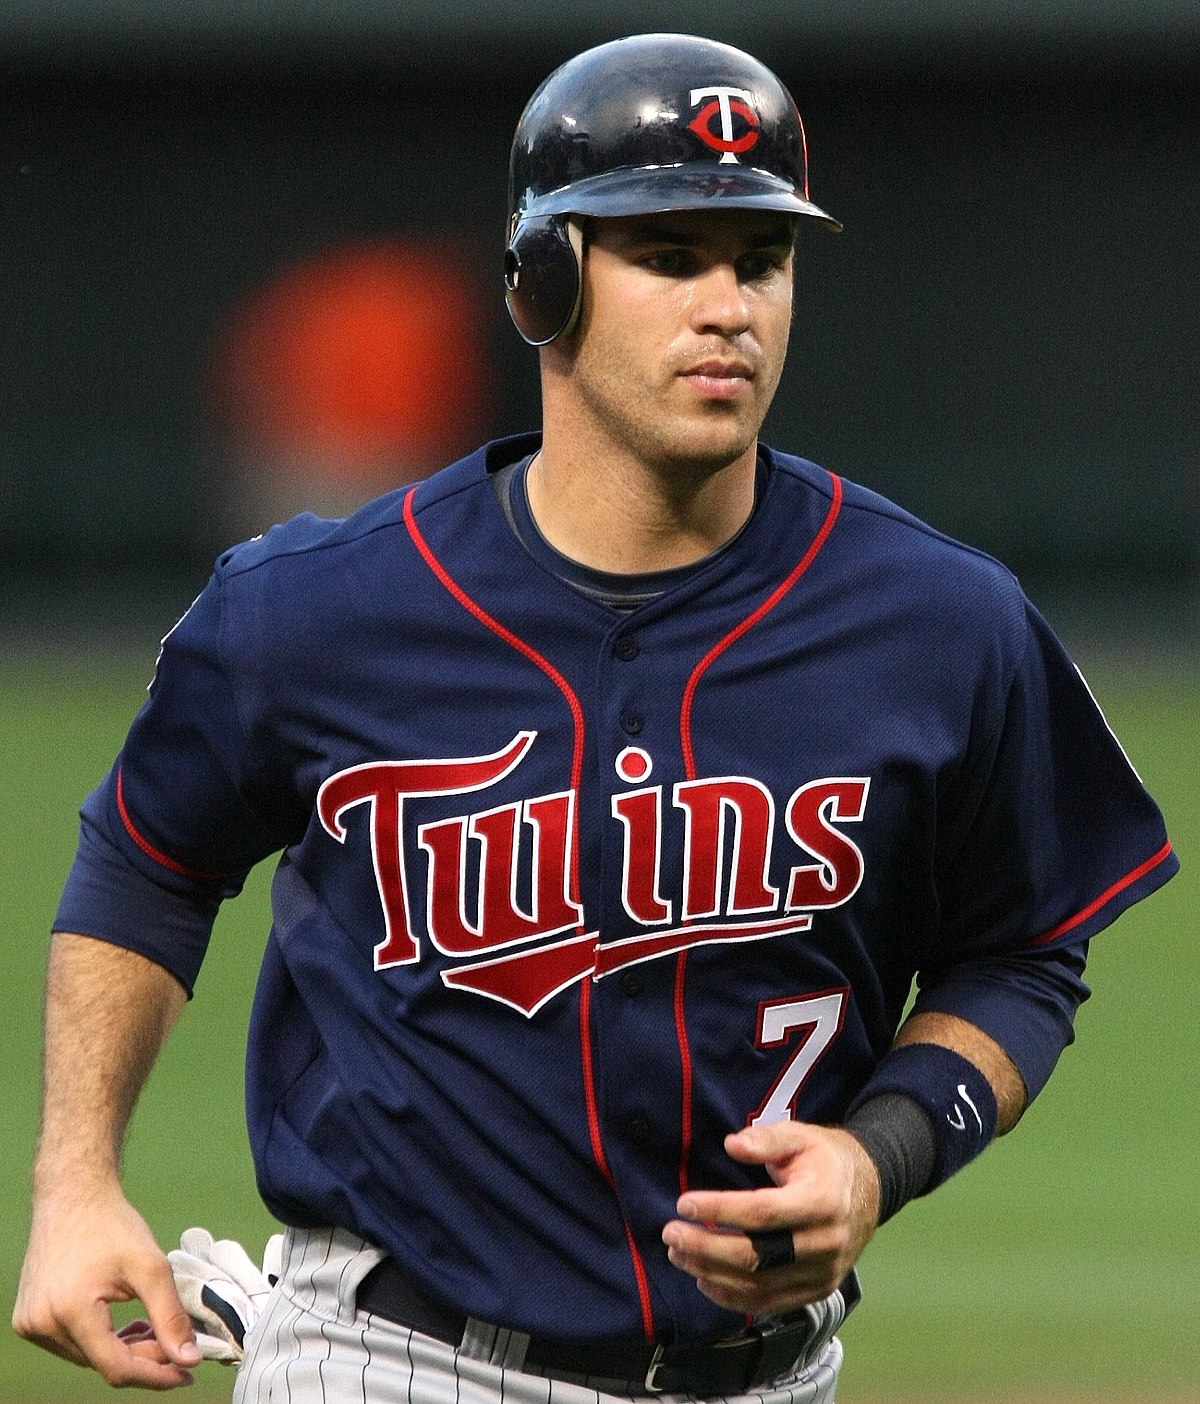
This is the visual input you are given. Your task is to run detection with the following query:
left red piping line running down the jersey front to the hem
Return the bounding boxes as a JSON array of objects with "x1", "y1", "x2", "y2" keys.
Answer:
[{"x1": 404, "y1": 487, "x2": 654, "y2": 1341}]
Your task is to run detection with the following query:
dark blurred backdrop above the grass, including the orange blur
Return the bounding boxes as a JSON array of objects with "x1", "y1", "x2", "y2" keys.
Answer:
[{"x1": 0, "y1": 0, "x2": 1200, "y2": 643}]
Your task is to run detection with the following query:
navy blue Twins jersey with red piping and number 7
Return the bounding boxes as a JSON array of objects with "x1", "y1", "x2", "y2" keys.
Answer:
[{"x1": 58, "y1": 438, "x2": 1178, "y2": 1341}]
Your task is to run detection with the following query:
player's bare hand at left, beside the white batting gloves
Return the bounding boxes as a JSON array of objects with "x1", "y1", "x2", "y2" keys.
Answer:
[{"x1": 13, "y1": 1186, "x2": 201, "y2": 1390}]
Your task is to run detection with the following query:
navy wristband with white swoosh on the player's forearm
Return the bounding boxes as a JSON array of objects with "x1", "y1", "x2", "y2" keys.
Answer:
[{"x1": 846, "y1": 1043, "x2": 996, "y2": 1213}]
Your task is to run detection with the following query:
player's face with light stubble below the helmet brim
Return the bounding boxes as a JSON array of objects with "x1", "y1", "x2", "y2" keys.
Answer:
[{"x1": 552, "y1": 211, "x2": 793, "y2": 473}]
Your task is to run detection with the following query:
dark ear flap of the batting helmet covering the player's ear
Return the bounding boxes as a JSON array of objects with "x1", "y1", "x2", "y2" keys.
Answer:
[{"x1": 504, "y1": 215, "x2": 584, "y2": 347}]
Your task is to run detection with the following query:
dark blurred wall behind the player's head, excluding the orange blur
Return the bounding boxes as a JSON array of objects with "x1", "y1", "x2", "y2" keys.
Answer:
[{"x1": 0, "y1": 32, "x2": 1200, "y2": 626}]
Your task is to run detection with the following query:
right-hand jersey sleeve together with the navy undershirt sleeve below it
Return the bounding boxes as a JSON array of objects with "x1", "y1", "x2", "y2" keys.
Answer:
[{"x1": 914, "y1": 601, "x2": 1179, "y2": 1102}]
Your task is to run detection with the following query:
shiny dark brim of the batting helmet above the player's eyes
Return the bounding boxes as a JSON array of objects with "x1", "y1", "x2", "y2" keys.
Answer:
[{"x1": 519, "y1": 161, "x2": 842, "y2": 230}]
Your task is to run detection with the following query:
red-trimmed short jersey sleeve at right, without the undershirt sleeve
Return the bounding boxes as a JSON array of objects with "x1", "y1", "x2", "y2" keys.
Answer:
[{"x1": 925, "y1": 601, "x2": 1179, "y2": 983}]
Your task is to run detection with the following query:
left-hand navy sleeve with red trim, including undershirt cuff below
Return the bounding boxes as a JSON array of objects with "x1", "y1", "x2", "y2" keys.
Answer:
[{"x1": 55, "y1": 553, "x2": 300, "y2": 991}]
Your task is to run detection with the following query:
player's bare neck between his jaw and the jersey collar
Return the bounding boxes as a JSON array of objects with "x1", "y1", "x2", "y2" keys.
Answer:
[{"x1": 526, "y1": 444, "x2": 756, "y2": 574}]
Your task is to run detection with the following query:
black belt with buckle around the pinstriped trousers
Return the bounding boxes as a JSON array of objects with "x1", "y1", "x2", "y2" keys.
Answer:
[{"x1": 356, "y1": 1258, "x2": 859, "y2": 1398}]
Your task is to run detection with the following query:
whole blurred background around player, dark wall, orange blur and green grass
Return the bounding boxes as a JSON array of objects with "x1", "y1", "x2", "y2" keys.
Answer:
[{"x1": 0, "y1": 0, "x2": 1200, "y2": 1404}]
